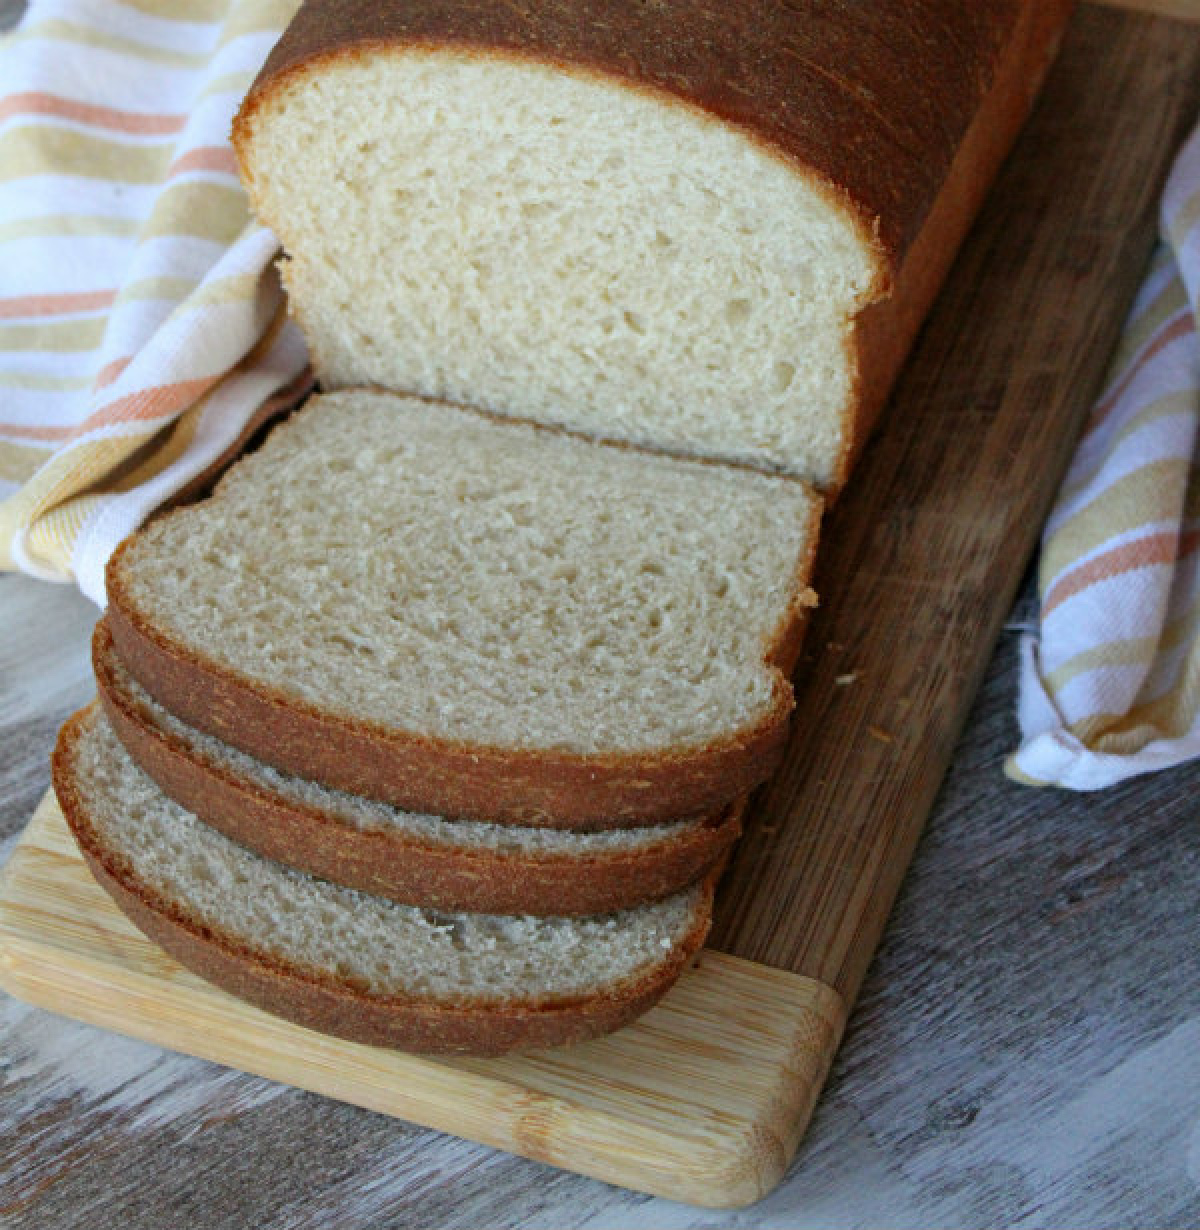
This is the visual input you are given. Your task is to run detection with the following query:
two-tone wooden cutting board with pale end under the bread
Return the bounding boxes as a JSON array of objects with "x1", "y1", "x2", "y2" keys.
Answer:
[{"x1": 0, "y1": 9, "x2": 1200, "y2": 1205}]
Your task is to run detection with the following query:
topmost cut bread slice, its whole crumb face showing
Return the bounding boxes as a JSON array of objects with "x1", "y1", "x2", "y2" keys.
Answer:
[{"x1": 107, "y1": 391, "x2": 820, "y2": 829}]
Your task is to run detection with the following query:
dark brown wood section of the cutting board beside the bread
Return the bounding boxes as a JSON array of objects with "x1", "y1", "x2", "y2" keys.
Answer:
[{"x1": 712, "y1": 9, "x2": 1200, "y2": 1002}]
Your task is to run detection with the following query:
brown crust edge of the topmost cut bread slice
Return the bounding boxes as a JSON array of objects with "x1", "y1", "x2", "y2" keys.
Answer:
[{"x1": 106, "y1": 494, "x2": 813, "y2": 829}]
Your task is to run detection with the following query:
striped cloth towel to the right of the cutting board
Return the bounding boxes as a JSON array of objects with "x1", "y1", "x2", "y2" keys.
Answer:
[{"x1": 1007, "y1": 117, "x2": 1200, "y2": 790}]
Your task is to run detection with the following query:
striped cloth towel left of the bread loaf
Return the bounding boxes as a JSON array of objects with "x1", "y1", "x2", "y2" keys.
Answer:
[{"x1": 0, "y1": 0, "x2": 307, "y2": 605}]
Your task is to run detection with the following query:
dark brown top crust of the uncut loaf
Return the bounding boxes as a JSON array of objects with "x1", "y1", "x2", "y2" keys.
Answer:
[{"x1": 237, "y1": 0, "x2": 1022, "y2": 276}]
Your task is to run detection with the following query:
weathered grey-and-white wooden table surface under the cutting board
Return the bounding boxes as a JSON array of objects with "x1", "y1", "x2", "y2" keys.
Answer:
[{"x1": 0, "y1": 0, "x2": 1200, "y2": 1230}]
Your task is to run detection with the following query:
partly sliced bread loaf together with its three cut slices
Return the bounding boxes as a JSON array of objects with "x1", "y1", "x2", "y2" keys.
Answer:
[{"x1": 54, "y1": 0, "x2": 1070, "y2": 1054}]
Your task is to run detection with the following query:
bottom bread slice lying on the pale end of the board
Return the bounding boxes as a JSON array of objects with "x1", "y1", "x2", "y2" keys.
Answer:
[{"x1": 54, "y1": 705, "x2": 712, "y2": 1055}]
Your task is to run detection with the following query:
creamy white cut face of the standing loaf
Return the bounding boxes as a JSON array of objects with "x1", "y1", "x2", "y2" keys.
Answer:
[{"x1": 235, "y1": 47, "x2": 883, "y2": 487}]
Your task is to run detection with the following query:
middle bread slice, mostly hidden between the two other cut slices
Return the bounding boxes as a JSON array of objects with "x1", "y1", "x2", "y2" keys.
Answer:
[{"x1": 92, "y1": 620, "x2": 741, "y2": 914}]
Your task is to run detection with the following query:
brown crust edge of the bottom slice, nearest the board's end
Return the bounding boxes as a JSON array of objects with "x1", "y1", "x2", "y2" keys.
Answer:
[{"x1": 53, "y1": 708, "x2": 713, "y2": 1055}]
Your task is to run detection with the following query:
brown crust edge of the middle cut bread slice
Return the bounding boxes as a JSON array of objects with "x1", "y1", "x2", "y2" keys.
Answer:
[{"x1": 92, "y1": 620, "x2": 741, "y2": 915}]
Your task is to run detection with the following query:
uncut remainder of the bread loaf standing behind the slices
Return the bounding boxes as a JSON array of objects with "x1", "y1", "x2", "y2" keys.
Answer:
[{"x1": 234, "y1": 0, "x2": 1071, "y2": 488}]
